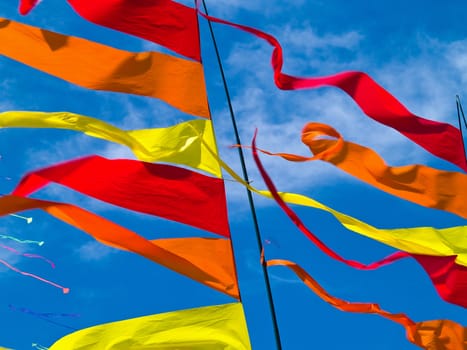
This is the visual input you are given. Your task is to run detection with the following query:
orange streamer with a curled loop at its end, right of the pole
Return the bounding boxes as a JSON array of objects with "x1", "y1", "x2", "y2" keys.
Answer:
[{"x1": 256, "y1": 122, "x2": 467, "y2": 218}]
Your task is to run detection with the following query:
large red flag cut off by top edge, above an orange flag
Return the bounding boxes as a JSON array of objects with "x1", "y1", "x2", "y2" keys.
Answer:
[{"x1": 68, "y1": 0, "x2": 201, "y2": 61}]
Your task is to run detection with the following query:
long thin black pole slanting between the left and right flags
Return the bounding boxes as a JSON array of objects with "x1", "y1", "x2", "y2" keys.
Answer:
[{"x1": 199, "y1": 0, "x2": 282, "y2": 350}]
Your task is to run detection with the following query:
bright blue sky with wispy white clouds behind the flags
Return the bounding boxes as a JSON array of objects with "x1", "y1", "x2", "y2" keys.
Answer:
[{"x1": 0, "y1": 0, "x2": 467, "y2": 350}]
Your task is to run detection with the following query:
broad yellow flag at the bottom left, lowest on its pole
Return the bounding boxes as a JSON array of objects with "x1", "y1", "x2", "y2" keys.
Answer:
[{"x1": 49, "y1": 303, "x2": 251, "y2": 350}]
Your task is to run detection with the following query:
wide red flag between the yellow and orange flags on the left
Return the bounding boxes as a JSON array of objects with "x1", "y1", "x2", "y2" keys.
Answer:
[{"x1": 12, "y1": 156, "x2": 230, "y2": 237}]
